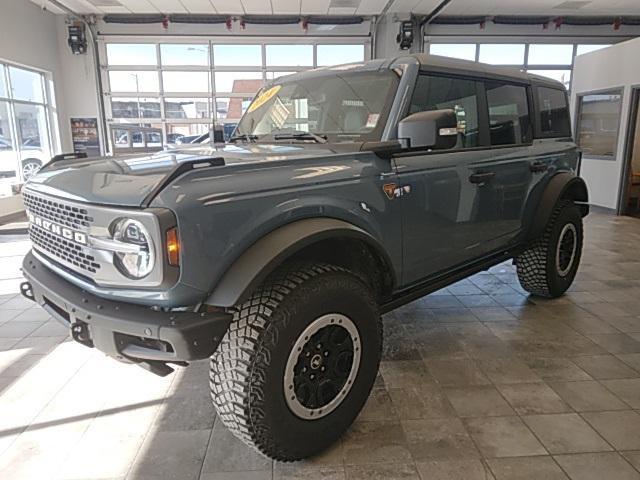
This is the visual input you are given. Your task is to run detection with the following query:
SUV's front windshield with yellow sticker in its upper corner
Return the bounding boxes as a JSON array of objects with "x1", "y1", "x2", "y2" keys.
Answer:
[{"x1": 235, "y1": 70, "x2": 398, "y2": 142}]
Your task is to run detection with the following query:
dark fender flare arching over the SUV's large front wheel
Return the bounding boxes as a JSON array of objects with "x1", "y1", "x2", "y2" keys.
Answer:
[{"x1": 204, "y1": 218, "x2": 395, "y2": 307}]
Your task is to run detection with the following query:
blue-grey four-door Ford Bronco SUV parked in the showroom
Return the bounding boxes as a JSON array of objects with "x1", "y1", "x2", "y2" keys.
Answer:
[{"x1": 22, "y1": 55, "x2": 588, "y2": 460}]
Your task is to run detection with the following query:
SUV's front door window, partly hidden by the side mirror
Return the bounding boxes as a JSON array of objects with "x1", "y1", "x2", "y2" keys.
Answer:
[{"x1": 409, "y1": 75, "x2": 480, "y2": 148}]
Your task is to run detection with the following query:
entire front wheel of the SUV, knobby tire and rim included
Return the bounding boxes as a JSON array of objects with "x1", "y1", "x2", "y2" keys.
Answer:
[{"x1": 210, "y1": 264, "x2": 382, "y2": 461}]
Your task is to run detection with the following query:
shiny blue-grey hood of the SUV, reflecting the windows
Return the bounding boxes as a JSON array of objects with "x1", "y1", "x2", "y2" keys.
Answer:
[{"x1": 26, "y1": 143, "x2": 361, "y2": 207}]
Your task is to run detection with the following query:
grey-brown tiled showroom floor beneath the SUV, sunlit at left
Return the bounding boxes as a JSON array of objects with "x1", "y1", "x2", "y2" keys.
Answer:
[{"x1": 0, "y1": 213, "x2": 640, "y2": 480}]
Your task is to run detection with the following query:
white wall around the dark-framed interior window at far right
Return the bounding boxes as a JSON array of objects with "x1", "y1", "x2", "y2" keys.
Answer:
[{"x1": 571, "y1": 38, "x2": 640, "y2": 209}]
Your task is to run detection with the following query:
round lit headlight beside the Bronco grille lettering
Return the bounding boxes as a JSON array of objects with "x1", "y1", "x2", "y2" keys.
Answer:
[{"x1": 113, "y1": 218, "x2": 156, "y2": 279}]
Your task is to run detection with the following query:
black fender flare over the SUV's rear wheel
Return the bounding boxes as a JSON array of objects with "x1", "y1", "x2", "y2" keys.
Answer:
[{"x1": 529, "y1": 172, "x2": 589, "y2": 238}]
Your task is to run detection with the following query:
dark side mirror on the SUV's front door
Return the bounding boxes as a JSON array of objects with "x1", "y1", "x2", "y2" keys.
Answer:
[{"x1": 398, "y1": 110, "x2": 458, "y2": 150}]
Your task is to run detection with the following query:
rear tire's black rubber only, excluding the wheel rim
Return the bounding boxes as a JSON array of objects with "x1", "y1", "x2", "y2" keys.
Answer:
[{"x1": 516, "y1": 200, "x2": 583, "y2": 298}]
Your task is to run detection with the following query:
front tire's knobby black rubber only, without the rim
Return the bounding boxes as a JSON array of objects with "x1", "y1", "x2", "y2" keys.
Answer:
[{"x1": 210, "y1": 264, "x2": 382, "y2": 461}]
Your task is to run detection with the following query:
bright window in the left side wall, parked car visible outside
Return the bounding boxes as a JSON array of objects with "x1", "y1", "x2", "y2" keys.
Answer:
[{"x1": 0, "y1": 62, "x2": 59, "y2": 196}]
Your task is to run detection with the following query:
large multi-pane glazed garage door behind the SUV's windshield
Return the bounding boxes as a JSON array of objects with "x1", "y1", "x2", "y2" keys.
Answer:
[{"x1": 101, "y1": 39, "x2": 370, "y2": 145}]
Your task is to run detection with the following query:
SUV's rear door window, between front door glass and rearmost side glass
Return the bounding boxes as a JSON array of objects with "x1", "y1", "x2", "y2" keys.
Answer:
[{"x1": 485, "y1": 82, "x2": 532, "y2": 145}]
